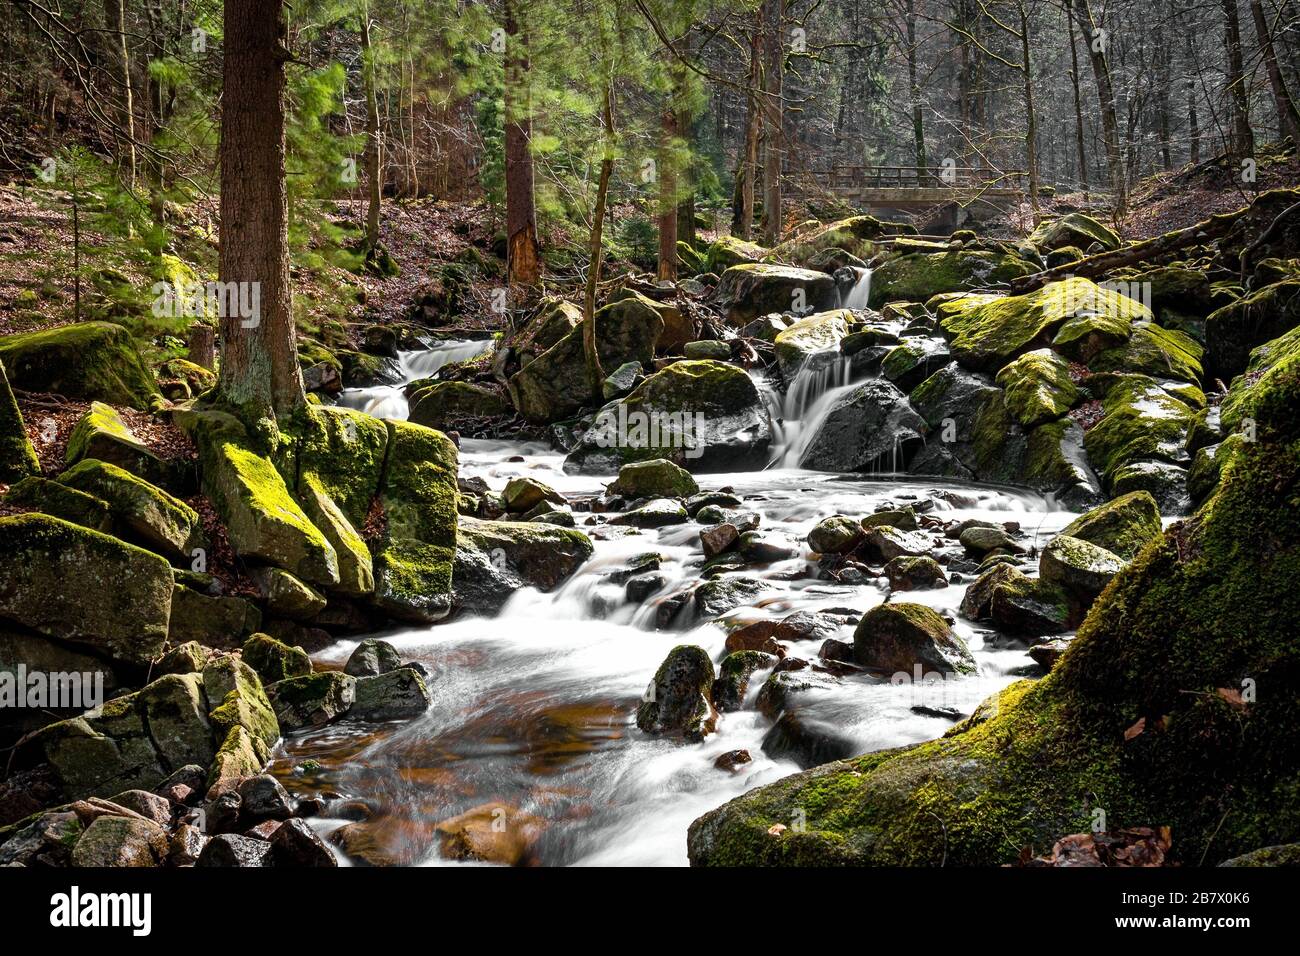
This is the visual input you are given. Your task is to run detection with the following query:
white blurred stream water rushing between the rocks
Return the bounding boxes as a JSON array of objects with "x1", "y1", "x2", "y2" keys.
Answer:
[{"x1": 273, "y1": 335, "x2": 1070, "y2": 865}]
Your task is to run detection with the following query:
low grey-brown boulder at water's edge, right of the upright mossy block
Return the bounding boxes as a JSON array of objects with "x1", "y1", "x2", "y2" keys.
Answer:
[{"x1": 452, "y1": 516, "x2": 594, "y2": 615}]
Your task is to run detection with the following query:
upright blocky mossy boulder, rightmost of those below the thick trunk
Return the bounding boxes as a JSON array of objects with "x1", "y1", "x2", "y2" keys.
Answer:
[{"x1": 373, "y1": 421, "x2": 458, "y2": 623}]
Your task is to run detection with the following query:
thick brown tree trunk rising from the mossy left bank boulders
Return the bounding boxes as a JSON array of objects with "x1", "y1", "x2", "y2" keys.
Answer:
[{"x1": 217, "y1": 0, "x2": 306, "y2": 416}]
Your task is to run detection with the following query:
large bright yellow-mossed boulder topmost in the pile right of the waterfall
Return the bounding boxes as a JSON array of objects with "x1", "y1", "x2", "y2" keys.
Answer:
[{"x1": 939, "y1": 276, "x2": 1152, "y2": 372}]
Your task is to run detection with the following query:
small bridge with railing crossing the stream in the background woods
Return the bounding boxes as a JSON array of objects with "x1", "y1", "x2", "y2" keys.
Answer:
[{"x1": 814, "y1": 166, "x2": 1028, "y2": 209}]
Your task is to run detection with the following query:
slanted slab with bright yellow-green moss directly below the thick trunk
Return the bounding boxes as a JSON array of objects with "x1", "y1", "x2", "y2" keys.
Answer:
[{"x1": 178, "y1": 411, "x2": 339, "y2": 587}]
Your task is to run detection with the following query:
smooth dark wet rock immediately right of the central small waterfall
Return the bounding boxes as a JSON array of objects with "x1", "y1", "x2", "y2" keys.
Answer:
[{"x1": 800, "y1": 378, "x2": 927, "y2": 471}]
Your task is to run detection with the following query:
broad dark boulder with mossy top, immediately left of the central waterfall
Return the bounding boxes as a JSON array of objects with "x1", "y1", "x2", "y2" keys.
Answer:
[{"x1": 564, "y1": 362, "x2": 772, "y2": 475}]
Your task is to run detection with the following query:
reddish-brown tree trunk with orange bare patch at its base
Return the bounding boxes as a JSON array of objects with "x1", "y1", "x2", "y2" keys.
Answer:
[{"x1": 506, "y1": 0, "x2": 542, "y2": 286}]
